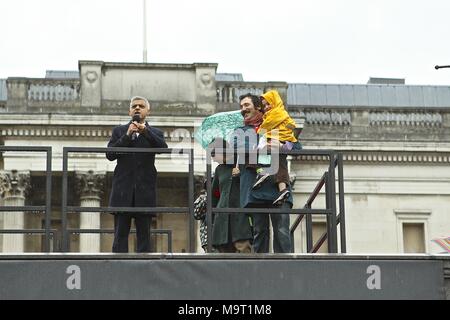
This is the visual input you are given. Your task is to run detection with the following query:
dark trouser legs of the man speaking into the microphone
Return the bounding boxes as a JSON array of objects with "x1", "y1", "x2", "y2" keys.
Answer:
[{"x1": 112, "y1": 212, "x2": 152, "y2": 252}]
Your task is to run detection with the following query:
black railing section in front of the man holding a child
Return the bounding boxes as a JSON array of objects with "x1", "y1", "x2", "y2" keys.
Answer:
[{"x1": 206, "y1": 149, "x2": 346, "y2": 253}]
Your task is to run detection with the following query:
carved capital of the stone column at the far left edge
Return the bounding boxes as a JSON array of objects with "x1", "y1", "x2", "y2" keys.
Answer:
[{"x1": 0, "y1": 170, "x2": 30, "y2": 199}]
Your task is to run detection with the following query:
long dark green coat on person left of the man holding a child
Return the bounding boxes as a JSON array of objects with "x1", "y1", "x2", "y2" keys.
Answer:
[{"x1": 212, "y1": 164, "x2": 253, "y2": 246}]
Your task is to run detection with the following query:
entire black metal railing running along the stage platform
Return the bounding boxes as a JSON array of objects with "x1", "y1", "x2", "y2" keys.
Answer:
[{"x1": 0, "y1": 146, "x2": 346, "y2": 253}]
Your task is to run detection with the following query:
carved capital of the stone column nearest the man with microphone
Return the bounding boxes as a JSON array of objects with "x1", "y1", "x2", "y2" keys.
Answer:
[{"x1": 75, "y1": 170, "x2": 106, "y2": 200}]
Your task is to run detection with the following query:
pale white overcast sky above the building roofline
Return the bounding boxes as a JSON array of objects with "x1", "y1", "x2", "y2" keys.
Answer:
[{"x1": 0, "y1": 0, "x2": 450, "y2": 85}]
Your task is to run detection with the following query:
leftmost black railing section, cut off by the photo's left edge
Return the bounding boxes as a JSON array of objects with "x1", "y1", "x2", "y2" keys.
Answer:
[{"x1": 0, "y1": 146, "x2": 53, "y2": 252}]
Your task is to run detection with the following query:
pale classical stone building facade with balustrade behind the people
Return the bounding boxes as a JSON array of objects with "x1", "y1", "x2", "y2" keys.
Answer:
[{"x1": 0, "y1": 61, "x2": 450, "y2": 253}]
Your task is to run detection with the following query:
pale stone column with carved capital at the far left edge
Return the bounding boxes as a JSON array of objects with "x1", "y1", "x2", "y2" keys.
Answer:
[{"x1": 0, "y1": 170, "x2": 30, "y2": 252}]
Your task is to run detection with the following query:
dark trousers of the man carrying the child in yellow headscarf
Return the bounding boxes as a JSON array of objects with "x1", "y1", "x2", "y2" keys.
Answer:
[{"x1": 252, "y1": 203, "x2": 292, "y2": 253}]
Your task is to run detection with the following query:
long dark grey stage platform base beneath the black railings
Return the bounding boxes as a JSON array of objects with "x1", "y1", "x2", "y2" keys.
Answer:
[{"x1": 0, "y1": 253, "x2": 450, "y2": 300}]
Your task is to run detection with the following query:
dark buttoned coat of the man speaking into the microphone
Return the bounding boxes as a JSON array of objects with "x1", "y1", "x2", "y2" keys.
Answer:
[{"x1": 106, "y1": 122, "x2": 167, "y2": 207}]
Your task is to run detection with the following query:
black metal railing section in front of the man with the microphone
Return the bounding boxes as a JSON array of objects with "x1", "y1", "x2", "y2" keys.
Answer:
[{"x1": 61, "y1": 147, "x2": 195, "y2": 252}]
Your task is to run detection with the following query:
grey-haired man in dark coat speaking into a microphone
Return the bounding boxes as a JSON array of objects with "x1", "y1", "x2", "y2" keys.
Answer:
[{"x1": 106, "y1": 96, "x2": 167, "y2": 252}]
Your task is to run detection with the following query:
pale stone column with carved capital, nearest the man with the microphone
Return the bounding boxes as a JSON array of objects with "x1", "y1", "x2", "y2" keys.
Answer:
[{"x1": 75, "y1": 170, "x2": 106, "y2": 252}]
